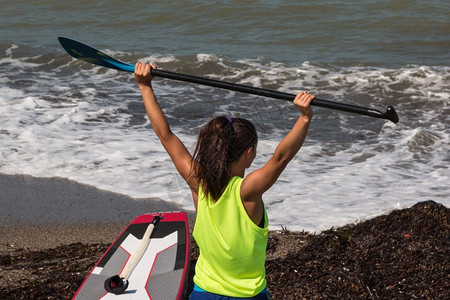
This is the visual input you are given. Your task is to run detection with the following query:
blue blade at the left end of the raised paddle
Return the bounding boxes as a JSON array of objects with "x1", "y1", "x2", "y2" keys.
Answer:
[{"x1": 58, "y1": 37, "x2": 134, "y2": 73}]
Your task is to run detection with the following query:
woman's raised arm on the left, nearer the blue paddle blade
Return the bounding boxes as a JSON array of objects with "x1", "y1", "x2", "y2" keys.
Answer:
[{"x1": 134, "y1": 63, "x2": 198, "y2": 191}]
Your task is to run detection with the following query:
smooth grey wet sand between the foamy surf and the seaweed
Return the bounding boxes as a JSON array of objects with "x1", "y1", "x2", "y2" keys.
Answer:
[{"x1": 0, "y1": 174, "x2": 195, "y2": 250}]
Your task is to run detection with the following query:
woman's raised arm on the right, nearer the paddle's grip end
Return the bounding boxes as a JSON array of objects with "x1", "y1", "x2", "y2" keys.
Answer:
[{"x1": 241, "y1": 92, "x2": 315, "y2": 202}]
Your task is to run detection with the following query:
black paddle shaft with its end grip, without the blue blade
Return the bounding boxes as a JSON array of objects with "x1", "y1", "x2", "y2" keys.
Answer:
[{"x1": 151, "y1": 69, "x2": 399, "y2": 123}]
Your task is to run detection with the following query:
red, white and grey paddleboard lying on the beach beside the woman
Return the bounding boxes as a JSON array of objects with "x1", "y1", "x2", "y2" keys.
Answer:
[{"x1": 72, "y1": 212, "x2": 190, "y2": 300}]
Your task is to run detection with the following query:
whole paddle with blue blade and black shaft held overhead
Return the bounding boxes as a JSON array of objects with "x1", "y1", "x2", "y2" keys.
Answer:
[{"x1": 58, "y1": 37, "x2": 399, "y2": 123}]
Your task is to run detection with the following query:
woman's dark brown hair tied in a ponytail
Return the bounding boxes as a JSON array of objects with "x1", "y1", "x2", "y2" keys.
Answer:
[{"x1": 194, "y1": 116, "x2": 258, "y2": 201}]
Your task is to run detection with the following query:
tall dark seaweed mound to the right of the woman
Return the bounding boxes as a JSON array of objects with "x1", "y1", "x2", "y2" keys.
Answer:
[{"x1": 267, "y1": 201, "x2": 450, "y2": 299}]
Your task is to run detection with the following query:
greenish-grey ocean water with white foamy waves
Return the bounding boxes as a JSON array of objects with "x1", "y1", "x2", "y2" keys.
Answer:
[{"x1": 0, "y1": 0, "x2": 450, "y2": 232}]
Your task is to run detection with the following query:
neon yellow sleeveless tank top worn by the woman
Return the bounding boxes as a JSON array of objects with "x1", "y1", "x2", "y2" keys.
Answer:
[{"x1": 193, "y1": 177, "x2": 268, "y2": 298}]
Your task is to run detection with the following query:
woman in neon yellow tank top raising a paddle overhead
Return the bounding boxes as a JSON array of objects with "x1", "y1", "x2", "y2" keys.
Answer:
[{"x1": 135, "y1": 63, "x2": 315, "y2": 299}]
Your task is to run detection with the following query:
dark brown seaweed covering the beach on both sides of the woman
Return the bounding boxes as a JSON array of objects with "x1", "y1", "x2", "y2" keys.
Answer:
[{"x1": 0, "y1": 201, "x2": 450, "y2": 299}]
